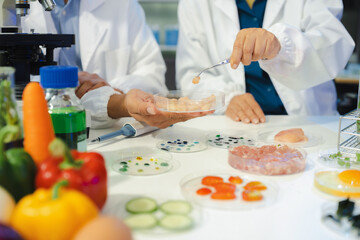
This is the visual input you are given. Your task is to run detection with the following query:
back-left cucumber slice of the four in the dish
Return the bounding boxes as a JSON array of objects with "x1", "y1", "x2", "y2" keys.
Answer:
[{"x1": 125, "y1": 197, "x2": 157, "y2": 214}]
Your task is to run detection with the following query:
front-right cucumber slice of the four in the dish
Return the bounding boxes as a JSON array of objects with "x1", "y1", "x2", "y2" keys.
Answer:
[{"x1": 159, "y1": 214, "x2": 193, "y2": 231}]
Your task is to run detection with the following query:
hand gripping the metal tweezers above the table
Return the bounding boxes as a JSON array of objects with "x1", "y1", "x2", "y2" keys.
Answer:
[{"x1": 230, "y1": 28, "x2": 281, "y2": 69}]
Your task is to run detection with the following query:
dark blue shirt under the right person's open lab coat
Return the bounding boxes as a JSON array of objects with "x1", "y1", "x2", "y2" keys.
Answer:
[{"x1": 236, "y1": 0, "x2": 287, "y2": 115}]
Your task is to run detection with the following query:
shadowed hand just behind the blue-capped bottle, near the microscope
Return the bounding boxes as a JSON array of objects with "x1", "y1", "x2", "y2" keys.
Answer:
[{"x1": 75, "y1": 72, "x2": 109, "y2": 98}]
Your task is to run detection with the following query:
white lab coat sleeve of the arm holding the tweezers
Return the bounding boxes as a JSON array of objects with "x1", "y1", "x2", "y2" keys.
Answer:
[{"x1": 259, "y1": 0, "x2": 355, "y2": 90}]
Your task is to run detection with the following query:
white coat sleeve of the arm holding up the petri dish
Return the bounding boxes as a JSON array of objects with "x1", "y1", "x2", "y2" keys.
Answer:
[{"x1": 108, "y1": 0, "x2": 167, "y2": 94}]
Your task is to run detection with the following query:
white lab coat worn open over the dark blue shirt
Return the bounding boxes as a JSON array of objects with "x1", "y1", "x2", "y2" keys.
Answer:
[{"x1": 176, "y1": 0, "x2": 354, "y2": 115}]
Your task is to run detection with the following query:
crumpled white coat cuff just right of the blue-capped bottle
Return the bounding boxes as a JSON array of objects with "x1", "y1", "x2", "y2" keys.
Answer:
[{"x1": 80, "y1": 86, "x2": 120, "y2": 128}]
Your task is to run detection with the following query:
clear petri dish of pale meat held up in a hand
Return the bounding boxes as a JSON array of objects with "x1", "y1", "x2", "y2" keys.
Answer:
[{"x1": 154, "y1": 90, "x2": 225, "y2": 113}]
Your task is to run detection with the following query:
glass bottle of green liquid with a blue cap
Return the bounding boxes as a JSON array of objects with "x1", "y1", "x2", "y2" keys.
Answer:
[{"x1": 40, "y1": 66, "x2": 86, "y2": 151}]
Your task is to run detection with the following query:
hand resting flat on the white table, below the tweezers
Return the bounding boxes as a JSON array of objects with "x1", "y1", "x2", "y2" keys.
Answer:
[{"x1": 226, "y1": 93, "x2": 265, "y2": 124}]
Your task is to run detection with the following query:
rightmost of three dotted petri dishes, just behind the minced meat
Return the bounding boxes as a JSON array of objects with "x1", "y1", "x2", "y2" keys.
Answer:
[{"x1": 207, "y1": 133, "x2": 256, "y2": 149}]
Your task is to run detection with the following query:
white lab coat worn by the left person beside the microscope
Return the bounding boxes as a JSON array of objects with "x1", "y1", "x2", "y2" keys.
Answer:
[{"x1": 22, "y1": 0, "x2": 167, "y2": 127}]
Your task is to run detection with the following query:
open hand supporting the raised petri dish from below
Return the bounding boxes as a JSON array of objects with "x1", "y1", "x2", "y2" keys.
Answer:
[{"x1": 124, "y1": 89, "x2": 214, "y2": 128}]
